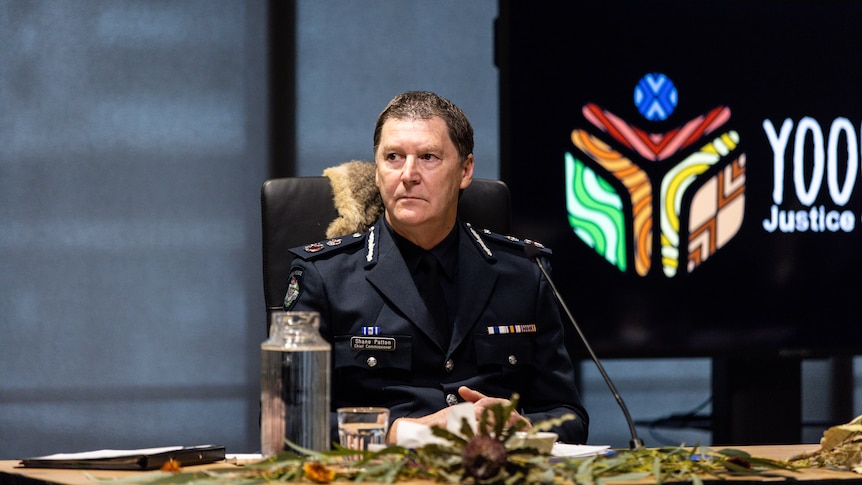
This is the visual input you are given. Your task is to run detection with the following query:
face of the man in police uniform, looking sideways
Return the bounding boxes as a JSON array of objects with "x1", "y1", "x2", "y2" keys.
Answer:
[{"x1": 374, "y1": 117, "x2": 473, "y2": 246}]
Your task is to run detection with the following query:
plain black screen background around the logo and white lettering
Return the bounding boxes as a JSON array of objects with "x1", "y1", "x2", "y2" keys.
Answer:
[{"x1": 497, "y1": 0, "x2": 862, "y2": 357}]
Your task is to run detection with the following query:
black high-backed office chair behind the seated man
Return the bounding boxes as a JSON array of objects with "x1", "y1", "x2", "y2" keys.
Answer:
[{"x1": 261, "y1": 165, "x2": 511, "y2": 325}]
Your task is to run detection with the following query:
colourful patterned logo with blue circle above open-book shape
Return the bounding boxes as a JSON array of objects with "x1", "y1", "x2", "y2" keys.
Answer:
[{"x1": 565, "y1": 73, "x2": 745, "y2": 278}]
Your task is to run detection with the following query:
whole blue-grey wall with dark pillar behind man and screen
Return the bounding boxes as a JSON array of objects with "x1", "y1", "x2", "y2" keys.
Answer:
[{"x1": 0, "y1": 0, "x2": 858, "y2": 459}]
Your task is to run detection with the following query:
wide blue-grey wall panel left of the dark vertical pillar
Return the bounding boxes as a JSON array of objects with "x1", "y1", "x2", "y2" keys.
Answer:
[{"x1": 0, "y1": 0, "x2": 268, "y2": 458}]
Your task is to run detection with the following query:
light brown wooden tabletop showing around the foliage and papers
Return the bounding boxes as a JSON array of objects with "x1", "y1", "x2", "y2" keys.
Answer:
[{"x1": 0, "y1": 444, "x2": 862, "y2": 485}]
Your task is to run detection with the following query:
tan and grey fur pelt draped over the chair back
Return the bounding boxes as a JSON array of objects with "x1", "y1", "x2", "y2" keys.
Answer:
[{"x1": 323, "y1": 160, "x2": 383, "y2": 238}]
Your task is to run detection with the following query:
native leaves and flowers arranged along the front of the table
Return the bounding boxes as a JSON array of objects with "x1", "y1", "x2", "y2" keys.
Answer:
[{"x1": 112, "y1": 395, "x2": 796, "y2": 485}]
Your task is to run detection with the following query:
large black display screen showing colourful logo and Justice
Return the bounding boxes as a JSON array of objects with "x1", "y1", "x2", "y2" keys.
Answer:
[{"x1": 496, "y1": 0, "x2": 862, "y2": 357}]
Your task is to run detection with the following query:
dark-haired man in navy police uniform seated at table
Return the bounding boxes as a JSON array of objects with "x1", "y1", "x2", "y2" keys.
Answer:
[{"x1": 285, "y1": 92, "x2": 588, "y2": 443}]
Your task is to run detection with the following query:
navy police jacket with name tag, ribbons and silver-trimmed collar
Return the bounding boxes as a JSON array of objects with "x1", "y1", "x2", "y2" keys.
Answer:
[{"x1": 285, "y1": 217, "x2": 588, "y2": 443}]
